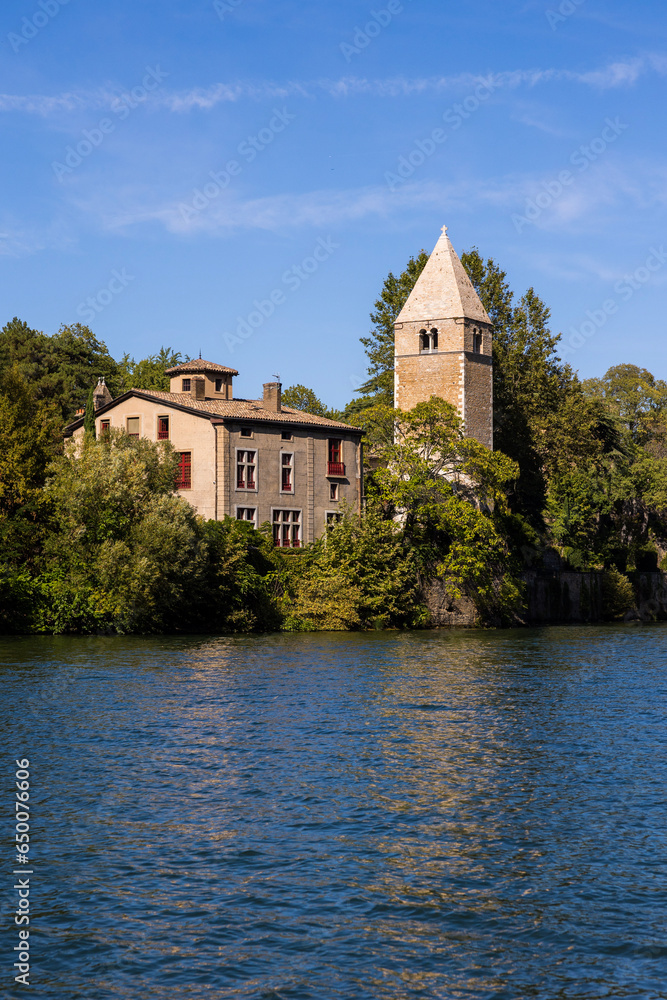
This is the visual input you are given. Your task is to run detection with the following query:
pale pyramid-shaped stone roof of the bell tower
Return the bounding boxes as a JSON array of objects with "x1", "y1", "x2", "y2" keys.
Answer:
[{"x1": 396, "y1": 226, "x2": 491, "y2": 323}]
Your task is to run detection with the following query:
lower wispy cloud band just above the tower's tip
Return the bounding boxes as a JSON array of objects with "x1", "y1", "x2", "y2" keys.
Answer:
[{"x1": 61, "y1": 153, "x2": 667, "y2": 245}]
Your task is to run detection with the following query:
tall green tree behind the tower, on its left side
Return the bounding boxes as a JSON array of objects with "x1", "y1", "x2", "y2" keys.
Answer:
[{"x1": 357, "y1": 250, "x2": 429, "y2": 406}]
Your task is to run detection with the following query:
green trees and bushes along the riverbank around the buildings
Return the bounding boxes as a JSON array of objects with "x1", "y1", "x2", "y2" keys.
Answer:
[{"x1": 0, "y1": 250, "x2": 667, "y2": 633}]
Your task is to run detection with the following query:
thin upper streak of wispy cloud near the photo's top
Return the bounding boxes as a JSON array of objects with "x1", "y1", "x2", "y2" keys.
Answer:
[{"x1": 0, "y1": 53, "x2": 667, "y2": 117}]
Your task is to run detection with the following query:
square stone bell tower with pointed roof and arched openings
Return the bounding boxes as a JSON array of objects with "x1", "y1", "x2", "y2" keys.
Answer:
[{"x1": 394, "y1": 226, "x2": 493, "y2": 448}]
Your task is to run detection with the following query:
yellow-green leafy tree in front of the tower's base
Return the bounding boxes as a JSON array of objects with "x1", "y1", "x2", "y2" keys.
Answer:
[{"x1": 358, "y1": 396, "x2": 522, "y2": 623}]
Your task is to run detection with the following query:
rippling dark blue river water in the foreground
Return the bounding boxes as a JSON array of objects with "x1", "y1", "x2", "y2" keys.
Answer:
[{"x1": 0, "y1": 625, "x2": 667, "y2": 1000}]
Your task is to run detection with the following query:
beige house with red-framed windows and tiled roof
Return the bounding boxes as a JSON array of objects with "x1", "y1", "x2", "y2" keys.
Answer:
[{"x1": 65, "y1": 359, "x2": 363, "y2": 548}]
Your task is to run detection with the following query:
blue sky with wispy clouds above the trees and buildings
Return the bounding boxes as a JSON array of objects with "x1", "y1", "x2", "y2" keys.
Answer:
[{"x1": 0, "y1": 0, "x2": 667, "y2": 406}]
